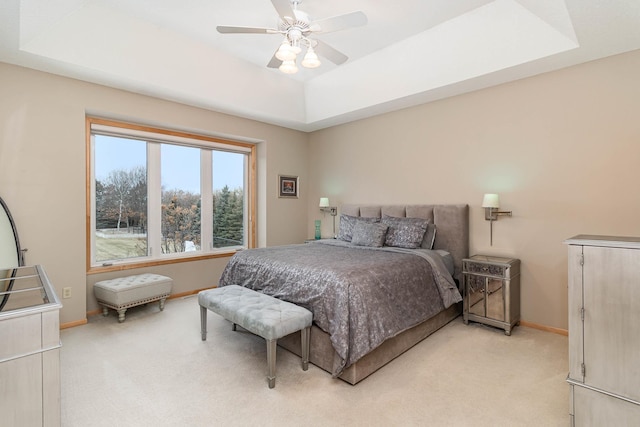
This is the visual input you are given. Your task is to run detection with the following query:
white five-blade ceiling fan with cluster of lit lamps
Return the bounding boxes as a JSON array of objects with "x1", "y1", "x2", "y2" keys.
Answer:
[{"x1": 217, "y1": 0, "x2": 367, "y2": 74}]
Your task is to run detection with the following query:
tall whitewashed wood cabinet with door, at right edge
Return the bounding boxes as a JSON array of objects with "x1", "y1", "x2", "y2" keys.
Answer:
[{"x1": 565, "y1": 235, "x2": 640, "y2": 426}]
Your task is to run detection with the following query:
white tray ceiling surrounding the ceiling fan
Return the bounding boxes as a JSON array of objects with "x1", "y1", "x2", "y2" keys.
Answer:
[{"x1": 0, "y1": 0, "x2": 640, "y2": 131}]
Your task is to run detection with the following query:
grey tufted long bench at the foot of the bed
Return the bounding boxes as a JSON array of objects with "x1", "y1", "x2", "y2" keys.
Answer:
[{"x1": 198, "y1": 285, "x2": 313, "y2": 388}]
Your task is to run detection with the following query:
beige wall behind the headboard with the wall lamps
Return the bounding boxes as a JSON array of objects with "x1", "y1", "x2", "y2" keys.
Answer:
[{"x1": 308, "y1": 51, "x2": 640, "y2": 329}]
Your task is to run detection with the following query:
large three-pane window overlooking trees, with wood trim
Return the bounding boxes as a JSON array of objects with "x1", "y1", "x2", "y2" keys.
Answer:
[{"x1": 87, "y1": 117, "x2": 255, "y2": 271}]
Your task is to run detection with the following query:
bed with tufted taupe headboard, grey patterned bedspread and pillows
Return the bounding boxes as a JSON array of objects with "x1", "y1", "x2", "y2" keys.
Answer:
[{"x1": 220, "y1": 205, "x2": 469, "y2": 384}]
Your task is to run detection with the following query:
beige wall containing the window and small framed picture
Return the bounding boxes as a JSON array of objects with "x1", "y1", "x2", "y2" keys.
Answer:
[{"x1": 0, "y1": 63, "x2": 308, "y2": 323}]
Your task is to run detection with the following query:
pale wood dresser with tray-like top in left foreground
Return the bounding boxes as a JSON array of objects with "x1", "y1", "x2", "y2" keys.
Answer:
[{"x1": 0, "y1": 265, "x2": 62, "y2": 427}]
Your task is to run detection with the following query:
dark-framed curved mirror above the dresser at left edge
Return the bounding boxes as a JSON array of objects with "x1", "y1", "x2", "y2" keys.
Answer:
[{"x1": 0, "y1": 197, "x2": 24, "y2": 311}]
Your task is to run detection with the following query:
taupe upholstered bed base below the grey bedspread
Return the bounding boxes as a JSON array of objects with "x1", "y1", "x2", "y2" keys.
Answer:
[{"x1": 278, "y1": 303, "x2": 462, "y2": 385}]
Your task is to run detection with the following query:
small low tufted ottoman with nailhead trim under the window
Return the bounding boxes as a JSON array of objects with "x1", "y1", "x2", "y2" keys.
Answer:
[{"x1": 93, "y1": 273, "x2": 173, "y2": 323}]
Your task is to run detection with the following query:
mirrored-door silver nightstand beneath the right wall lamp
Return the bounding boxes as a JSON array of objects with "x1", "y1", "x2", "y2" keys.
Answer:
[{"x1": 462, "y1": 255, "x2": 520, "y2": 335}]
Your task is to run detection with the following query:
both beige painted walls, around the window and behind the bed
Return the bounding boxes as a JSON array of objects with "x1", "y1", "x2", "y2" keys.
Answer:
[{"x1": 5, "y1": 51, "x2": 640, "y2": 328}]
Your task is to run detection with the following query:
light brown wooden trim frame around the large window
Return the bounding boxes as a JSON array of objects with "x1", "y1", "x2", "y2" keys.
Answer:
[{"x1": 85, "y1": 116, "x2": 257, "y2": 274}]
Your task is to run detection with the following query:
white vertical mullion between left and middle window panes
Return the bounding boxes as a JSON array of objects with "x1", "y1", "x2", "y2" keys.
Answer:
[{"x1": 147, "y1": 142, "x2": 162, "y2": 258}]
